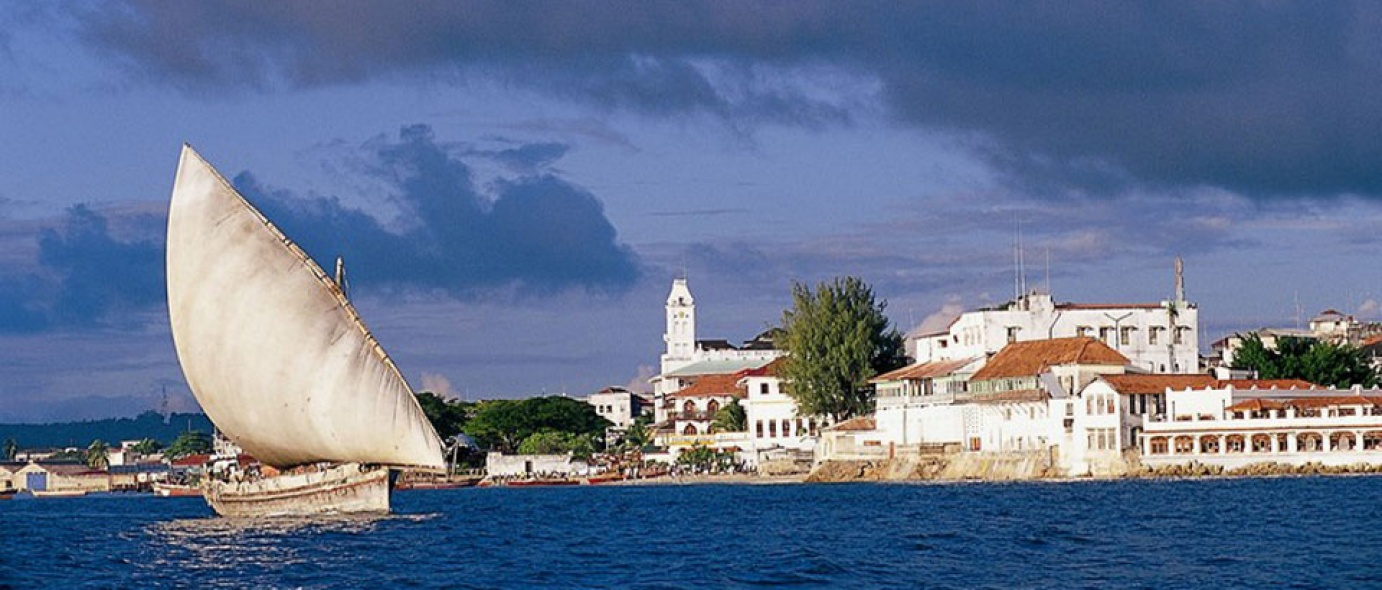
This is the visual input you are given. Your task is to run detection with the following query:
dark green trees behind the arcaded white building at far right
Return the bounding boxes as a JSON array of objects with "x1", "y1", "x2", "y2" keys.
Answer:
[{"x1": 1233, "y1": 334, "x2": 1379, "y2": 387}]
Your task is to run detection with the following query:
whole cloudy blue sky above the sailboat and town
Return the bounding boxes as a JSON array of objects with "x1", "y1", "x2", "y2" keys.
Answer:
[{"x1": 0, "y1": 0, "x2": 1382, "y2": 421}]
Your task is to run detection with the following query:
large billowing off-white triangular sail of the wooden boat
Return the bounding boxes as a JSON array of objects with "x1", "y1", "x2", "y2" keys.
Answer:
[{"x1": 167, "y1": 145, "x2": 444, "y2": 468}]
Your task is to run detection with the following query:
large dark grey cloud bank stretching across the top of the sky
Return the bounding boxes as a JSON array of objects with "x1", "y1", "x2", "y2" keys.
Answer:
[{"x1": 77, "y1": 0, "x2": 1382, "y2": 196}]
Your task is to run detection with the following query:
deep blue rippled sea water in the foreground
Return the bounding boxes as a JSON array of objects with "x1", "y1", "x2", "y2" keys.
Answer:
[{"x1": 0, "y1": 477, "x2": 1382, "y2": 589}]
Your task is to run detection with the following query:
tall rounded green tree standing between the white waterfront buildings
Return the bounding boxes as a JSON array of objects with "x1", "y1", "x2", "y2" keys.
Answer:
[{"x1": 782, "y1": 276, "x2": 907, "y2": 420}]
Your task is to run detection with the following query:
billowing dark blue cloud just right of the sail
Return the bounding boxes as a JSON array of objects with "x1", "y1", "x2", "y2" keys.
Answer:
[{"x1": 235, "y1": 126, "x2": 638, "y2": 298}]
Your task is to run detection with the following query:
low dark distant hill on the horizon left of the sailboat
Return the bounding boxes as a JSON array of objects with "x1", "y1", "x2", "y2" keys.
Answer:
[{"x1": 0, "y1": 412, "x2": 211, "y2": 449}]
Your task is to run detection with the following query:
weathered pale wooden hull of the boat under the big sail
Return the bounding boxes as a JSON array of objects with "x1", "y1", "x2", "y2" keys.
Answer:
[{"x1": 203, "y1": 463, "x2": 398, "y2": 517}]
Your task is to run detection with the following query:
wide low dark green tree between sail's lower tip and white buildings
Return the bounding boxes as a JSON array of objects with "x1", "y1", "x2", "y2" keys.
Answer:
[{"x1": 464, "y1": 395, "x2": 611, "y2": 452}]
